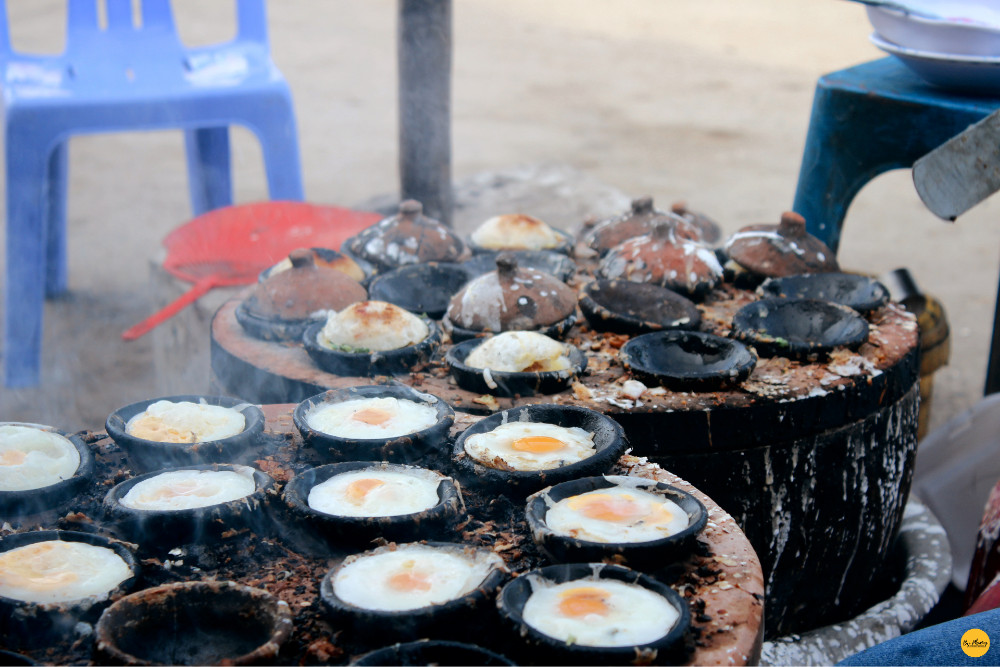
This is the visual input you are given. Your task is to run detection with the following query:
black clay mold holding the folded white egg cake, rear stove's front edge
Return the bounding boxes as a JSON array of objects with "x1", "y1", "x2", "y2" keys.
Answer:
[{"x1": 444, "y1": 338, "x2": 587, "y2": 397}]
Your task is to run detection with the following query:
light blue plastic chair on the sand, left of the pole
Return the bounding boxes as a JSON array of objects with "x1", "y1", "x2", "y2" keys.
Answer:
[{"x1": 0, "y1": 0, "x2": 303, "y2": 387}]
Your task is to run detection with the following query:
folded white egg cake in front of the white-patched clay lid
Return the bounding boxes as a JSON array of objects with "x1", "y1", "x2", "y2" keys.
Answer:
[{"x1": 465, "y1": 331, "x2": 572, "y2": 373}]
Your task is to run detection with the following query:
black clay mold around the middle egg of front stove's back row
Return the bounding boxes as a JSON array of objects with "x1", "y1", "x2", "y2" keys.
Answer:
[{"x1": 292, "y1": 384, "x2": 455, "y2": 463}]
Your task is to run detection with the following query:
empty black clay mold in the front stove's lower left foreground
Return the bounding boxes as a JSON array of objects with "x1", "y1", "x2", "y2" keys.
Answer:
[{"x1": 94, "y1": 581, "x2": 292, "y2": 665}]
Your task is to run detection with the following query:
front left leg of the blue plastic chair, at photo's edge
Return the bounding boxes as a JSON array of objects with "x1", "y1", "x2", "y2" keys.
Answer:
[{"x1": 3, "y1": 126, "x2": 52, "y2": 387}]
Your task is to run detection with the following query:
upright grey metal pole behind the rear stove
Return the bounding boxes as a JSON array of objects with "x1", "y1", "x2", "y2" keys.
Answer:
[{"x1": 397, "y1": 0, "x2": 453, "y2": 225}]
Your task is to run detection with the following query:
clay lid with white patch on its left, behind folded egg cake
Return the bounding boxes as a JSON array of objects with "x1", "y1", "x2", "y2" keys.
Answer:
[{"x1": 445, "y1": 253, "x2": 576, "y2": 333}]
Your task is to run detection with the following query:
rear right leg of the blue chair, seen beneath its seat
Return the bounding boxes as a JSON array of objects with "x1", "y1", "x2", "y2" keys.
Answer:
[{"x1": 184, "y1": 127, "x2": 233, "y2": 216}]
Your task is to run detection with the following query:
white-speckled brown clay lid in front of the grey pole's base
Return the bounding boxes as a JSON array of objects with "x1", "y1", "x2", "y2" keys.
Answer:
[{"x1": 347, "y1": 199, "x2": 469, "y2": 271}]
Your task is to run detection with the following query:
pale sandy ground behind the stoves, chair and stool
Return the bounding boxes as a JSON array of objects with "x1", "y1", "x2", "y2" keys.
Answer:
[{"x1": 0, "y1": 0, "x2": 1000, "y2": 444}]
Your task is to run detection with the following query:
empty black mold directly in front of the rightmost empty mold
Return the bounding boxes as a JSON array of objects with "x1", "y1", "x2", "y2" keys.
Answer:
[{"x1": 730, "y1": 299, "x2": 868, "y2": 359}]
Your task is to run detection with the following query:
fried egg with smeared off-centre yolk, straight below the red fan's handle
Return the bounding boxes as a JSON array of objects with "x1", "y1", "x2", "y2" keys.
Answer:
[{"x1": 125, "y1": 401, "x2": 246, "y2": 442}]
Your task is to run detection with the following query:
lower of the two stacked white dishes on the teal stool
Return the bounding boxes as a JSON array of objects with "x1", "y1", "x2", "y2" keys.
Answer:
[{"x1": 869, "y1": 33, "x2": 1000, "y2": 95}]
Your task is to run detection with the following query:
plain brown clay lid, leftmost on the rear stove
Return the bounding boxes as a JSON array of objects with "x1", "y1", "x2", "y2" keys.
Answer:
[{"x1": 244, "y1": 248, "x2": 368, "y2": 320}]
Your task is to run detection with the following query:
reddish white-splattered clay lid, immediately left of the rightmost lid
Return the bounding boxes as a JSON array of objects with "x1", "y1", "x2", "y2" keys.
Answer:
[{"x1": 597, "y1": 221, "x2": 722, "y2": 297}]
